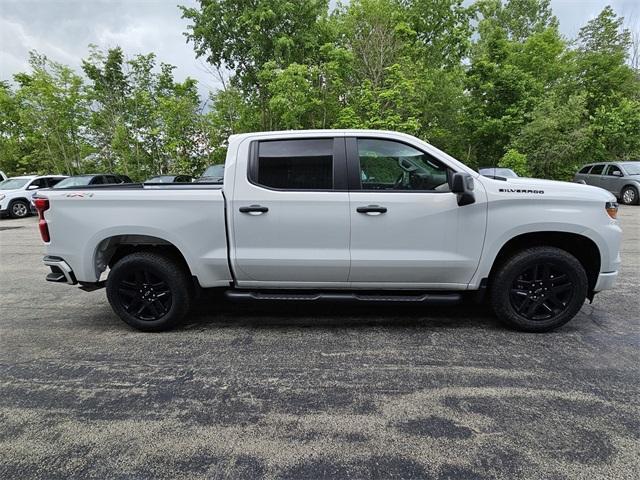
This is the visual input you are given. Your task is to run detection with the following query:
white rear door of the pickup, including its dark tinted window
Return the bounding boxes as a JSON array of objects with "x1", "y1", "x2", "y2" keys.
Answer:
[{"x1": 228, "y1": 137, "x2": 350, "y2": 287}]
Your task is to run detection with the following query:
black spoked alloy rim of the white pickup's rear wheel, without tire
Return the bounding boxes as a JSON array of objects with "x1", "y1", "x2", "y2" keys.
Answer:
[{"x1": 118, "y1": 267, "x2": 173, "y2": 322}]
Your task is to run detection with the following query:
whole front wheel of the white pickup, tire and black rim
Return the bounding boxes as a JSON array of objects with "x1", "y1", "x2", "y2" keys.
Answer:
[{"x1": 491, "y1": 247, "x2": 588, "y2": 332}]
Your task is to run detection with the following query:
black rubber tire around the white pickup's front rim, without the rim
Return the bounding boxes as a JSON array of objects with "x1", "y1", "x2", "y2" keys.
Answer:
[{"x1": 490, "y1": 247, "x2": 589, "y2": 333}]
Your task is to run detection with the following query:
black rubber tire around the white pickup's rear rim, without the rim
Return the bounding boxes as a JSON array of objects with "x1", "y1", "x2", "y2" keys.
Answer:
[{"x1": 107, "y1": 252, "x2": 193, "y2": 332}]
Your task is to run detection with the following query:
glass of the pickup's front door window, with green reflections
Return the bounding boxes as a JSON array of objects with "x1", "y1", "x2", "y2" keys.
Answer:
[{"x1": 358, "y1": 138, "x2": 449, "y2": 191}]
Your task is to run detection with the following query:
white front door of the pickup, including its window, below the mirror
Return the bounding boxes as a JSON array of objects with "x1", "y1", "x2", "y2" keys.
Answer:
[{"x1": 346, "y1": 138, "x2": 486, "y2": 289}]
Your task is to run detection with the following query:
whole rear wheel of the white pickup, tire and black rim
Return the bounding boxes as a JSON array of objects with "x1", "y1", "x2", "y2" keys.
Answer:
[{"x1": 107, "y1": 252, "x2": 192, "y2": 332}]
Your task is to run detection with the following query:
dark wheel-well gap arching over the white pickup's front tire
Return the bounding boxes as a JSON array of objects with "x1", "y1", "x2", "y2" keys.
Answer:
[{"x1": 489, "y1": 231, "x2": 602, "y2": 292}]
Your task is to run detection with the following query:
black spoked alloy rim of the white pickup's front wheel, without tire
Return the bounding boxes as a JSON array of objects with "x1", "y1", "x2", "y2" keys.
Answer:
[{"x1": 509, "y1": 261, "x2": 574, "y2": 321}]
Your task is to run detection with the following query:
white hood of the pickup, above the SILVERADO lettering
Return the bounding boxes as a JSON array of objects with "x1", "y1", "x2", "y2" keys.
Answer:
[{"x1": 481, "y1": 177, "x2": 616, "y2": 202}]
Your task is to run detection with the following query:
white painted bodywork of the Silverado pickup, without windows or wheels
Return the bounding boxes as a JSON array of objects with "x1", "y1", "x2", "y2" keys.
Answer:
[{"x1": 40, "y1": 130, "x2": 621, "y2": 291}]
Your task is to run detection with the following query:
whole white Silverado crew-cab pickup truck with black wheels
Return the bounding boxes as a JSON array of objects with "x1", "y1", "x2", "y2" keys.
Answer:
[{"x1": 35, "y1": 130, "x2": 621, "y2": 332}]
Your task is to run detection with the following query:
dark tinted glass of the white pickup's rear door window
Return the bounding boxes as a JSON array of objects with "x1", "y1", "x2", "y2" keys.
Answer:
[{"x1": 251, "y1": 138, "x2": 333, "y2": 190}]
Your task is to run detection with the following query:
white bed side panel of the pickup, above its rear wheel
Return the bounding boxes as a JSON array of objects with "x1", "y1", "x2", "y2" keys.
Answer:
[{"x1": 38, "y1": 183, "x2": 231, "y2": 287}]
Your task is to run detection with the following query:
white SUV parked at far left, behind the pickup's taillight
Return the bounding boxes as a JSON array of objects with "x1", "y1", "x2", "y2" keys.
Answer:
[{"x1": 0, "y1": 175, "x2": 67, "y2": 218}]
